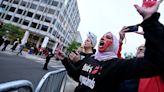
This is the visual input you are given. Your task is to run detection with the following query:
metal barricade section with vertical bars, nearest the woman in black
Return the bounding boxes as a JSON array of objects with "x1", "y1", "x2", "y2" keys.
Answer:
[{"x1": 35, "y1": 68, "x2": 67, "y2": 92}]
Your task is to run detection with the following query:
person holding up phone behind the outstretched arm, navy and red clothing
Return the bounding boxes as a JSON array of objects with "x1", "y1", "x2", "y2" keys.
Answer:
[{"x1": 118, "y1": 20, "x2": 164, "y2": 92}]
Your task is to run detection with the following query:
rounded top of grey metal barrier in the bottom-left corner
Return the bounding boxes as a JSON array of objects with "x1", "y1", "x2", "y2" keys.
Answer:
[{"x1": 0, "y1": 80, "x2": 33, "y2": 92}]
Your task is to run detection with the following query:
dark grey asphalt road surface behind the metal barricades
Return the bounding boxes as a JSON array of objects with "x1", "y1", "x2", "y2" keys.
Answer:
[{"x1": 0, "y1": 53, "x2": 56, "y2": 88}]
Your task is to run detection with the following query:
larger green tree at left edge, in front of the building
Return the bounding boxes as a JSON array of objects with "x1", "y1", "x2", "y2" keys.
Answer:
[{"x1": 0, "y1": 23, "x2": 24, "y2": 40}]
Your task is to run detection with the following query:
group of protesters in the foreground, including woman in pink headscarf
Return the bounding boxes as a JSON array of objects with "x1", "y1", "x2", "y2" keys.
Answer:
[{"x1": 55, "y1": 0, "x2": 164, "y2": 92}]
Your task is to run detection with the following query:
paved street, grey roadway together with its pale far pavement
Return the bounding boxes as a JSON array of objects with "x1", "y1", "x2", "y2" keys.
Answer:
[{"x1": 0, "y1": 48, "x2": 77, "y2": 92}]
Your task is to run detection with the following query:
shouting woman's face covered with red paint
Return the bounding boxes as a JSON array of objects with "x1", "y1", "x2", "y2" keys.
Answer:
[{"x1": 99, "y1": 35, "x2": 113, "y2": 52}]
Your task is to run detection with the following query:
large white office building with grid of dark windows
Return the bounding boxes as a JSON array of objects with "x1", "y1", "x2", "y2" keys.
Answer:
[{"x1": 0, "y1": 0, "x2": 80, "y2": 50}]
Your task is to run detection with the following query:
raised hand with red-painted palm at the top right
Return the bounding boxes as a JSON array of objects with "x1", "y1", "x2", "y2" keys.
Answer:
[{"x1": 134, "y1": 0, "x2": 163, "y2": 20}]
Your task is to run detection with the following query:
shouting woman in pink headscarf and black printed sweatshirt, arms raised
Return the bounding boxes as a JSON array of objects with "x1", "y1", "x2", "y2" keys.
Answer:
[{"x1": 56, "y1": 0, "x2": 164, "y2": 92}]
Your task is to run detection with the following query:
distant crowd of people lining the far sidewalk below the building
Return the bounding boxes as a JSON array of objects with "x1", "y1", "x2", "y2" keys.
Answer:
[{"x1": 0, "y1": 36, "x2": 50, "y2": 56}]
